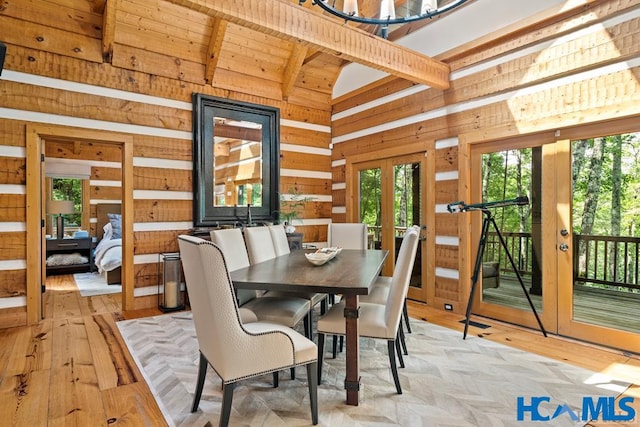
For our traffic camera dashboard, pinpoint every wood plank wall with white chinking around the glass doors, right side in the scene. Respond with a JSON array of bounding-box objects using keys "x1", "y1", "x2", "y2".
[{"x1": 331, "y1": 0, "x2": 640, "y2": 312}]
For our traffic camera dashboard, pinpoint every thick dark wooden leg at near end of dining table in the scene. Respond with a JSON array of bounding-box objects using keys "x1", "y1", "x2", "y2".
[{"x1": 344, "y1": 295, "x2": 360, "y2": 406}]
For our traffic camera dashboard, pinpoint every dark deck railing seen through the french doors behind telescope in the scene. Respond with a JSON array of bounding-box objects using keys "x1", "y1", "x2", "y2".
[{"x1": 483, "y1": 232, "x2": 640, "y2": 289}]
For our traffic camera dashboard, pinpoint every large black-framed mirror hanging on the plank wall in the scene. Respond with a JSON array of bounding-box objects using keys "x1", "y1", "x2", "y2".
[{"x1": 193, "y1": 93, "x2": 280, "y2": 227}]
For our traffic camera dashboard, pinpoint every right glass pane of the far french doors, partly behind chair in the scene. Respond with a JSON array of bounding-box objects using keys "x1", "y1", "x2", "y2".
[{"x1": 393, "y1": 163, "x2": 422, "y2": 288}]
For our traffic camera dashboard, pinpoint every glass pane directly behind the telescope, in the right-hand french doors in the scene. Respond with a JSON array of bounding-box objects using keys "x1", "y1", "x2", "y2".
[{"x1": 478, "y1": 147, "x2": 543, "y2": 312}]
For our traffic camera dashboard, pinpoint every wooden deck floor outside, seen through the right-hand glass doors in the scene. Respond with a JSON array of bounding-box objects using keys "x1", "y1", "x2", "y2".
[{"x1": 483, "y1": 275, "x2": 640, "y2": 333}]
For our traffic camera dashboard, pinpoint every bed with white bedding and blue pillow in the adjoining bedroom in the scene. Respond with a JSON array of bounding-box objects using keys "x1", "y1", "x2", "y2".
[{"x1": 94, "y1": 203, "x2": 122, "y2": 285}]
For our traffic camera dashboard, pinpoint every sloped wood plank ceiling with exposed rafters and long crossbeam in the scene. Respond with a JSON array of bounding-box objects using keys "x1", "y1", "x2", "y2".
[{"x1": 0, "y1": 0, "x2": 458, "y2": 108}]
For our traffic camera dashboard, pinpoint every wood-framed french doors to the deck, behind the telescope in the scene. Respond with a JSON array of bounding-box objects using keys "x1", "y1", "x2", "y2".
[{"x1": 470, "y1": 124, "x2": 640, "y2": 352}]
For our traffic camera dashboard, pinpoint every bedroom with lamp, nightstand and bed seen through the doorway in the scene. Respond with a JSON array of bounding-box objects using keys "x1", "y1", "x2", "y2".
[{"x1": 44, "y1": 137, "x2": 122, "y2": 302}]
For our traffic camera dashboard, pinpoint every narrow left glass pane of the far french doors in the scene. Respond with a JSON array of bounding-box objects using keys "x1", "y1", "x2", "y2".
[{"x1": 358, "y1": 168, "x2": 382, "y2": 249}]
